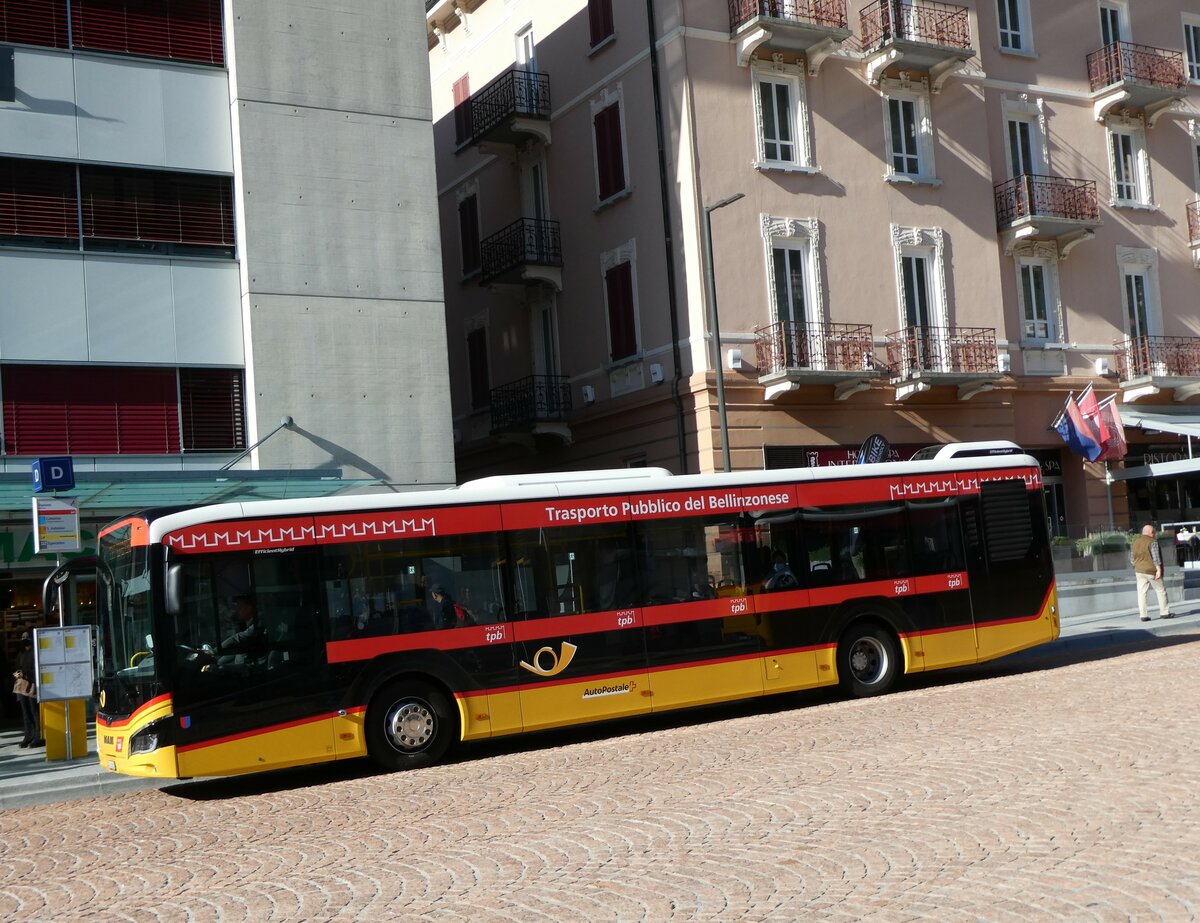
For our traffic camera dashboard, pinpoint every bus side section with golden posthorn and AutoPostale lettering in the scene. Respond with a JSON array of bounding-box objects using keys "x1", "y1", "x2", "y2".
[{"x1": 509, "y1": 522, "x2": 650, "y2": 731}]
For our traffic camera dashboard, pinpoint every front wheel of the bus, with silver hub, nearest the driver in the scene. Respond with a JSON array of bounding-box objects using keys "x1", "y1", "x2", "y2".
[{"x1": 366, "y1": 679, "x2": 458, "y2": 772}]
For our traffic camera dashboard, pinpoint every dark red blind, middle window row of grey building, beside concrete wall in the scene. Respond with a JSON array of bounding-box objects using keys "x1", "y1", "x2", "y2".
[{"x1": 79, "y1": 167, "x2": 234, "y2": 247}]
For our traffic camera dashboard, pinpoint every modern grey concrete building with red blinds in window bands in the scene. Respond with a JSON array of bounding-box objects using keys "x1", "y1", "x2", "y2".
[{"x1": 0, "y1": 0, "x2": 455, "y2": 633}]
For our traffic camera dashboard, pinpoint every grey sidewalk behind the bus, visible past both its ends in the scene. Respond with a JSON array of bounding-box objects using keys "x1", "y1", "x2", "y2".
[{"x1": 0, "y1": 593, "x2": 1200, "y2": 810}]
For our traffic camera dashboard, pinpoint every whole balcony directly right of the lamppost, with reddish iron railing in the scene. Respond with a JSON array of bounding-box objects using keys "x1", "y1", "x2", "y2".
[{"x1": 755, "y1": 320, "x2": 880, "y2": 401}]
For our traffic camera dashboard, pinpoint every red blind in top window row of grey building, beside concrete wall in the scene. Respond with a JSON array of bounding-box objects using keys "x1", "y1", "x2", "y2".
[{"x1": 71, "y1": 0, "x2": 224, "y2": 65}]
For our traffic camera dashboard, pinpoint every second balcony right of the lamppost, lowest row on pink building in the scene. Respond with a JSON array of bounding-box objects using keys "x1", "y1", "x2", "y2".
[{"x1": 886, "y1": 326, "x2": 1001, "y2": 401}]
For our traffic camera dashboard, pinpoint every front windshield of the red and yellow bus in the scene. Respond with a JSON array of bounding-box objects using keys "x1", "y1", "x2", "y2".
[{"x1": 96, "y1": 521, "x2": 158, "y2": 714}]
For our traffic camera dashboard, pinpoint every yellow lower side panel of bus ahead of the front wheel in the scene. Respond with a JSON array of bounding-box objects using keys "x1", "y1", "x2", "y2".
[{"x1": 179, "y1": 718, "x2": 335, "y2": 778}]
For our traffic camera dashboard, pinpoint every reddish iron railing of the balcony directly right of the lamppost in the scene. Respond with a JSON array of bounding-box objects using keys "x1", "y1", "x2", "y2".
[{"x1": 755, "y1": 320, "x2": 875, "y2": 374}]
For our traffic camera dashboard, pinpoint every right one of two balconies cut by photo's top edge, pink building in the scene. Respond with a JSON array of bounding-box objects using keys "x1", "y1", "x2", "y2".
[{"x1": 859, "y1": 0, "x2": 974, "y2": 92}]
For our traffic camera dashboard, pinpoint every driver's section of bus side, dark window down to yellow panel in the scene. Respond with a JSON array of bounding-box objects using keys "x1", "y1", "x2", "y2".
[{"x1": 173, "y1": 549, "x2": 335, "y2": 777}]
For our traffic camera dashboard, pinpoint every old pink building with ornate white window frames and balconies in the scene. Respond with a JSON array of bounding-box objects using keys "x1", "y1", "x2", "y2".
[{"x1": 426, "y1": 0, "x2": 1200, "y2": 534}]
